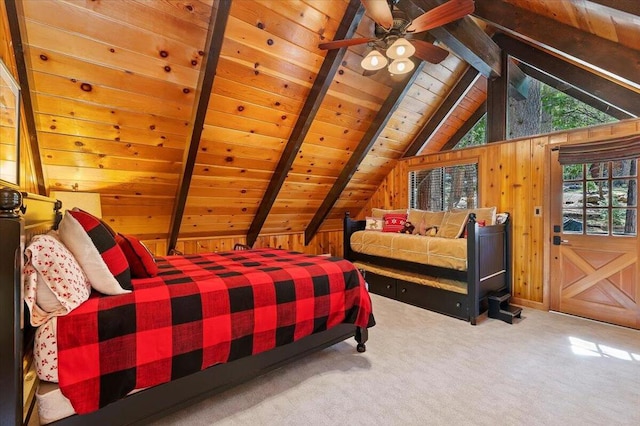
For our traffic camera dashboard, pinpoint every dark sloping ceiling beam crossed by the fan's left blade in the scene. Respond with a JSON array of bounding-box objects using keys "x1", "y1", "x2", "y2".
[{"x1": 247, "y1": 0, "x2": 364, "y2": 246}]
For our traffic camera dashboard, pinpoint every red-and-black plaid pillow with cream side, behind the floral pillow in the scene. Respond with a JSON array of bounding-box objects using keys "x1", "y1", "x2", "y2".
[{"x1": 58, "y1": 210, "x2": 131, "y2": 295}]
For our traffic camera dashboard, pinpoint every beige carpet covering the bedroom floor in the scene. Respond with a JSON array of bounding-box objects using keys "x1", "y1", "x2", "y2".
[{"x1": 153, "y1": 295, "x2": 640, "y2": 426}]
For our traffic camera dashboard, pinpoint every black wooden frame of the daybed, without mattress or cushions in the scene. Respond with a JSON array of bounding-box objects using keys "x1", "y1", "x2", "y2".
[{"x1": 344, "y1": 212, "x2": 511, "y2": 325}]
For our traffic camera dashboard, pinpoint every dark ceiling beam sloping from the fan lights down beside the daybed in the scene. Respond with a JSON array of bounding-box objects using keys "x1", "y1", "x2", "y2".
[{"x1": 304, "y1": 62, "x2": 425, "y2": 245}]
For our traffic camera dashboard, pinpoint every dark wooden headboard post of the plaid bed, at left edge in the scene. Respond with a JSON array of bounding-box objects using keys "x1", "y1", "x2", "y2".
[{"x1": 0, "y1": 188, "x2": 24, "y2": 425}]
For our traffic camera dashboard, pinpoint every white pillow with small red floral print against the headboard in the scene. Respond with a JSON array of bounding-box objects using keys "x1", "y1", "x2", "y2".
[{"x1": 24, "y1": 235, "x2": 91, "y2": 327}]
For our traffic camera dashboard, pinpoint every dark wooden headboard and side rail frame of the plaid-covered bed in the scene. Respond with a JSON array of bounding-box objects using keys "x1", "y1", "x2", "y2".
[{"x1": 0, "y1": 188, "x2": 368, "y2": 426}]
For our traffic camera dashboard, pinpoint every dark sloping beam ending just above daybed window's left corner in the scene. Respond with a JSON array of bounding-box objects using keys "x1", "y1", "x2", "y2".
[{"x1": 403, "y1": 67, "x2": 480, "y2": 158}]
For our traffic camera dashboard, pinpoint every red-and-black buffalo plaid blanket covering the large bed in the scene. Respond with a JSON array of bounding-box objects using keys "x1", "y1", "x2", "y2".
[{"x1": 58, "y1": 249, "x2": 375, "y2": 414}]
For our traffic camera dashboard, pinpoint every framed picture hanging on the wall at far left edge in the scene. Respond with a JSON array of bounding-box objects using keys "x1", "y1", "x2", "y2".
[{"x1": 0, "y1": 60, "x2": 20, "y2": 185}]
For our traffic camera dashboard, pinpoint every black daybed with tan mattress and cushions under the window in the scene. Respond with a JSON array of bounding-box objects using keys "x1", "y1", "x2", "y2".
[{"x1": 344, "y1": 209, "x2": 519, "y2": 325}]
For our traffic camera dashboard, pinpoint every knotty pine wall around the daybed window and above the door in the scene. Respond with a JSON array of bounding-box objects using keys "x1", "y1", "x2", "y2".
[{"x1": 357, "y1": 119, "x2": 640, "y2": 309}]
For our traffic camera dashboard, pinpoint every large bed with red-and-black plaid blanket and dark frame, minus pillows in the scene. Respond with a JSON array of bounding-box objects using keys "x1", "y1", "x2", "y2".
[{"x1": 0, "y1": 188, "x2": 375, "y2": 425}]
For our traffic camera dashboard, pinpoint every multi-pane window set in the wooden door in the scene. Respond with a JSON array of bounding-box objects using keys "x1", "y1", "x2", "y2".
[{"x1": 562, "y1": 159, "x2": 638, "y2": 236}]
